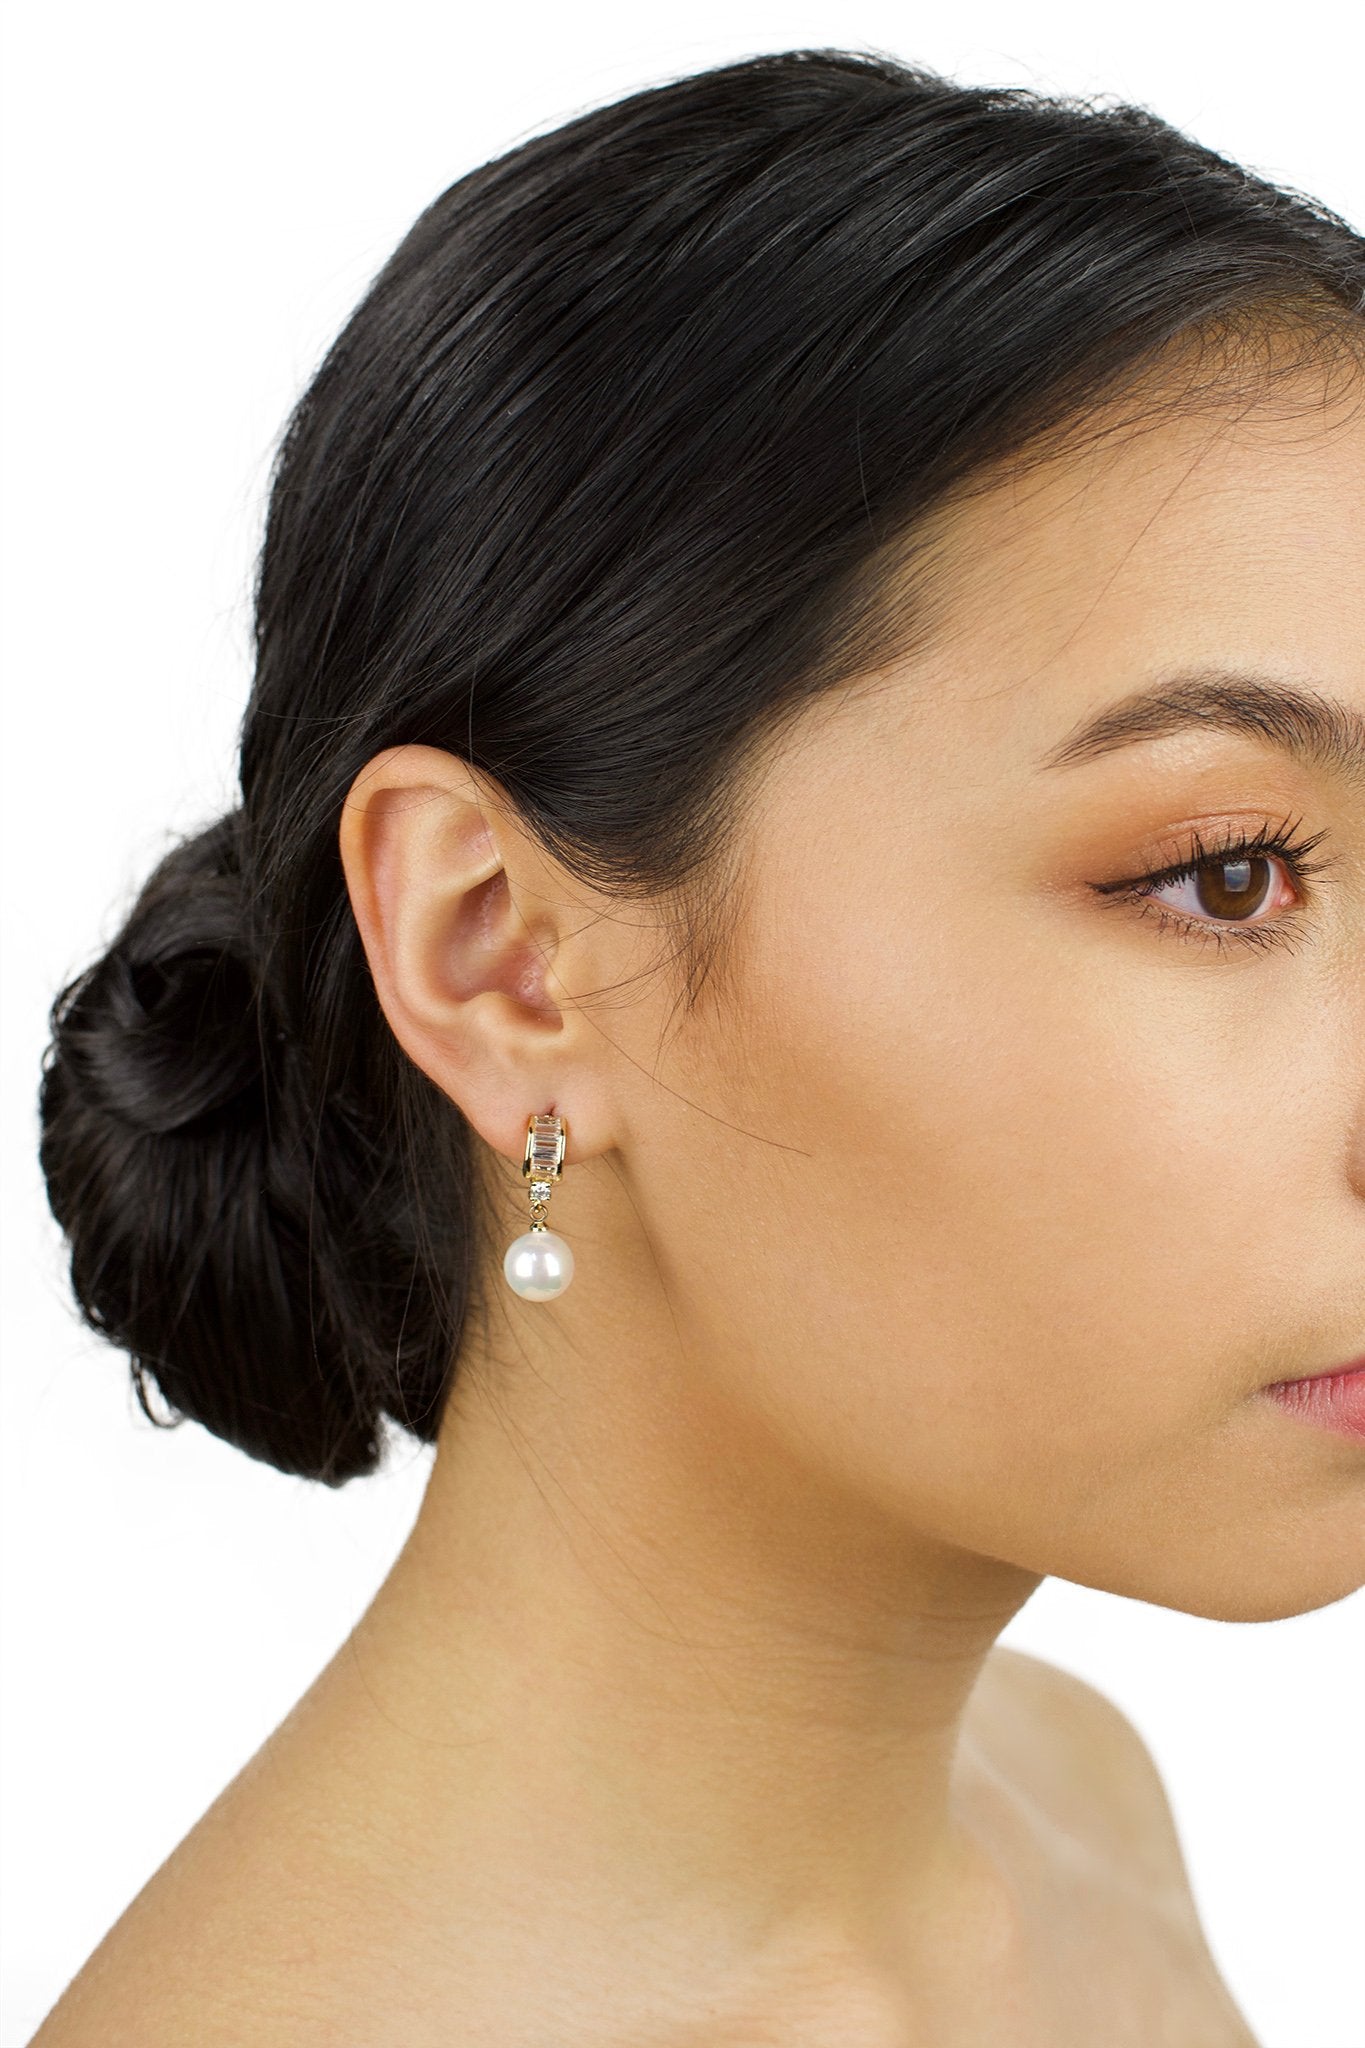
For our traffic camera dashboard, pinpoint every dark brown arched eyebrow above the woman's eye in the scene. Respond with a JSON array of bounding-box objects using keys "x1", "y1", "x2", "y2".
[{"x1": 1036, "y1": 668, "x2": 1365, "y2": 784}]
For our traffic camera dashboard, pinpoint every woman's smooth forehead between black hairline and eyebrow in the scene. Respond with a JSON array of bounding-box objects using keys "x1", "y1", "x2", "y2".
[{"x1": 863, "y1": 367, "x2": 1365, "y2": 748}]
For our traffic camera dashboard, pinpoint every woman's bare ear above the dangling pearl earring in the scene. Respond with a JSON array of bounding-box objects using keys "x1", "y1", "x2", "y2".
[{"x1": 340, "y1": 745, "x2": 620, "y2": 1165}]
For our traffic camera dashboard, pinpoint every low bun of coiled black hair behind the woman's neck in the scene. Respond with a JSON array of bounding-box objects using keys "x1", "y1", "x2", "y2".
[{"x1": 39, "y1": 811, "x2": 463, "y2": 1485}]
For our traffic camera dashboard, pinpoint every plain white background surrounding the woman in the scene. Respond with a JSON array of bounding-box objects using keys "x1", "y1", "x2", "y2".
[{"x1": 0, "y1": 0, "x2": 1365, "y2": 2048}]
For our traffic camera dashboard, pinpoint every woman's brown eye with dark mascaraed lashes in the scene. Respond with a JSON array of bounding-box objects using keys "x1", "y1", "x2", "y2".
[{"x1": 1095, "y1": 823, "x2": 1334, "y2": 950}]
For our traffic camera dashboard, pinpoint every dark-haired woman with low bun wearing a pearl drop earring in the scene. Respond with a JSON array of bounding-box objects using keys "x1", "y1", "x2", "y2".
[{"x1": 37, "y1": 39, "x2": 1365, "y2": 2048}]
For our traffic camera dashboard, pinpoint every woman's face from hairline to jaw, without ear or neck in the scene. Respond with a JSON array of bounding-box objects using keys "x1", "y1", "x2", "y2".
[{"x1": 581, "y1": 360, "x2": 1365, "y2": 1618}]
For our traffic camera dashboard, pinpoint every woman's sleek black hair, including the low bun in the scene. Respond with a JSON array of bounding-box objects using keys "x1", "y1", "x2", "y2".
[{"x1": 39, "y1": 49, "x2": 1365, "y2": 1485}]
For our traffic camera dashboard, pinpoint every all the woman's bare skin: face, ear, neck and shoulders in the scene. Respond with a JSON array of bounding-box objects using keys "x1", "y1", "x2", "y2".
[{"x1": 26, "y1": 360, "x2": 1365, "y2": 2048}]
